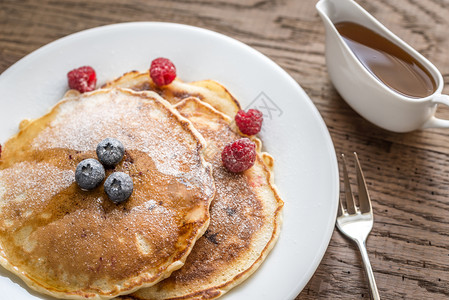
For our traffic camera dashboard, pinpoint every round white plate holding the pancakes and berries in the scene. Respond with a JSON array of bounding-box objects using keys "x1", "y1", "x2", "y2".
[{"x1": 0, "y1": 22, "x2": 339, "y2": 300}]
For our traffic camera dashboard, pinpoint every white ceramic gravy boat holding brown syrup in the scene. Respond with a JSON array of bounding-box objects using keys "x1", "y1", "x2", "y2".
[{"x1": 316, "y1": 0, "x2": 449, "y2": 132}]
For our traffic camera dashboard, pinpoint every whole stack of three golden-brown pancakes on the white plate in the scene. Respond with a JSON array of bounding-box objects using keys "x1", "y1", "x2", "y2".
[{"x1": 0, "y1": 72, "x2": 283, "y2": 299}]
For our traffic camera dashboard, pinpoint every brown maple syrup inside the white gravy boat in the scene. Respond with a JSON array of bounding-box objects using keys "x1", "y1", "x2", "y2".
[{"x1": 335, "y1": 22, "x2": 437, "y2": 98}]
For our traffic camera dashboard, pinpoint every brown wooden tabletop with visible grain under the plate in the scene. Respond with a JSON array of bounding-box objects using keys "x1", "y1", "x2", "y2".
[{"x1": 0, "y1": 0, "x2": 449, "y2": 300}]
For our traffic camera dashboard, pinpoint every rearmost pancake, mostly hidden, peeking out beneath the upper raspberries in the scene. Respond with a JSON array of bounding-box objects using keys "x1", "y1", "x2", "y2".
[{"x1": 103, "y1": 71, "x2": 240, "y2": 118}]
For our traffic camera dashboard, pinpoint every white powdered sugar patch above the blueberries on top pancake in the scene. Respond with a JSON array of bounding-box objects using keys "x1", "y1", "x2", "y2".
[{"x1": 32, "y1": 88, "x2": 197, "y2": 176}]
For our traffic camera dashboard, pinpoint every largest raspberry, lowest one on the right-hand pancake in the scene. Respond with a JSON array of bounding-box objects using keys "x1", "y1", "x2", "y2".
[{"x1": 221, "y1": 138, "x2": 256, "y2": 173}]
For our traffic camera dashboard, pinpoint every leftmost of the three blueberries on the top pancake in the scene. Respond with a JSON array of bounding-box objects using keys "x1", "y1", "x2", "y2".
[{"x1": 75, "y1": 158, "x2": 105, "y2": 190}]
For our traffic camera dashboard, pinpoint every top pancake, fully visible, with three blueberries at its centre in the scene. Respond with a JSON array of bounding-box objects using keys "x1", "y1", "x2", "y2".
[{"x1": 0, "y1": 89, "x2": 215, "y2": 299}]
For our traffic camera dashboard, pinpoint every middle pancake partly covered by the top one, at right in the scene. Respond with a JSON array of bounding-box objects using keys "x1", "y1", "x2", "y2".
[{"x1": 117, "y1": 98, "x2": 283, "y2": 300}]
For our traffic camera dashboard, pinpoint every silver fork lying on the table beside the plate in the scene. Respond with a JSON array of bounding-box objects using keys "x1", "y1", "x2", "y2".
[{"x1": 337, "y1": 152, "x2": 380, "y2": 300}]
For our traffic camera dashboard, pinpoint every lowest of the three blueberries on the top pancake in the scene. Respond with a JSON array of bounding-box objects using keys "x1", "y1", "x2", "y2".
[{"x1": 104, "y1": 172, "x2": 133, "y2": 203}]
